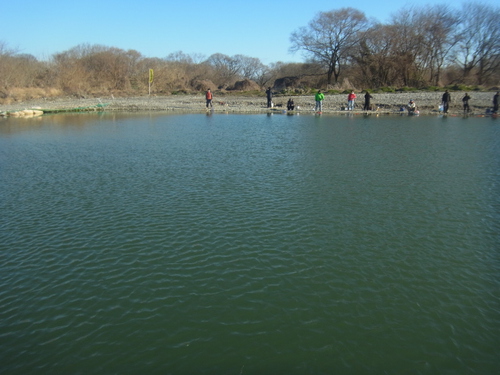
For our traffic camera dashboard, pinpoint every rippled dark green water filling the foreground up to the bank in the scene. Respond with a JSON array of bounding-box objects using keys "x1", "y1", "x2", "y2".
[{"x1": 0, "y1": 114, "x2": 500, "y2": 375}]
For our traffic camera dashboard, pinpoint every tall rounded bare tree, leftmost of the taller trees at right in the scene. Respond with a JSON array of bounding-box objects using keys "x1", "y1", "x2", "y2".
[{"x1": 290, "y1": 8, "x2": 369, "y2": 84}]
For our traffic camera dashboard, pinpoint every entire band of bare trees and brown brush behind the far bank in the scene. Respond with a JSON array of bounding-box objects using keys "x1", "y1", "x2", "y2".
[{"x1": 0, "y1": 3, "x2": 500, "y2": 103}]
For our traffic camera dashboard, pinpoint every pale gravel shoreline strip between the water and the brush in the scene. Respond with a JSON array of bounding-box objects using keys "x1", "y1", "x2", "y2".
[{"x1": 0, "y1": 92, "x2": 495, "y2": 115}]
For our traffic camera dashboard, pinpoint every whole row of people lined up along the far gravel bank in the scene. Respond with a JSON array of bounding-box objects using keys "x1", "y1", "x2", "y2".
[{"x1": 205, "y1": 87, "x2": 499, "y2": 114}]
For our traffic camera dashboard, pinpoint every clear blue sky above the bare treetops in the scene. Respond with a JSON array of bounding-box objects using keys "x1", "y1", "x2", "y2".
[{"x1": 0, "y1": 0, "x2": 498, "y2": 64}]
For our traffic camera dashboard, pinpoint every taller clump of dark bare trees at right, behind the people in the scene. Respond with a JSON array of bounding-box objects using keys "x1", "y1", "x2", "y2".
[{"x1": 291, "y1": 3, "x2": 500, "y2": 87}]
